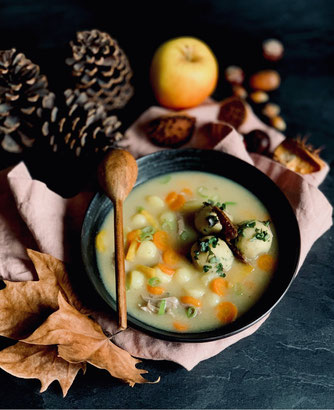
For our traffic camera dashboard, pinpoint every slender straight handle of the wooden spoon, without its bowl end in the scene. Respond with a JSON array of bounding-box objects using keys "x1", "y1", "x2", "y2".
[{"x1": 114, "y1": 199, "x2": 127, "y2": 330}]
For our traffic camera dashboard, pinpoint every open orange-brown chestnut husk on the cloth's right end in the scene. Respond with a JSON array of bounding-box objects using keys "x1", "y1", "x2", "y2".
[{"x1": 274, "y1": 138, "x2": 325, "y2": 174}]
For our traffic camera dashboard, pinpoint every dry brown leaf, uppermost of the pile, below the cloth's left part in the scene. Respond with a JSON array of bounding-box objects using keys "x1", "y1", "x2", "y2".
[{"x1": 0, "y1": 249, "x2": 81, "y2": 340}]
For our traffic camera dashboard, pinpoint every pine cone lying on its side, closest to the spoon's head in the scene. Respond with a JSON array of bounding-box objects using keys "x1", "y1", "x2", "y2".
[{"x1": 38, "y1": 89, "x2": 123, "y2": 157}]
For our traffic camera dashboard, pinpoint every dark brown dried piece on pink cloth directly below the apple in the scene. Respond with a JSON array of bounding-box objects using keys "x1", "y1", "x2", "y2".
[{"x1": 146, "y1": 114, "x2": 196, "y2": 148}]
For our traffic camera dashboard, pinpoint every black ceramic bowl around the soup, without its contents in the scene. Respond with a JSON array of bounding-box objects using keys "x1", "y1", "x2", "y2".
[{"x1": 81, "y1": 149, "x2": 300, "y2": 342}]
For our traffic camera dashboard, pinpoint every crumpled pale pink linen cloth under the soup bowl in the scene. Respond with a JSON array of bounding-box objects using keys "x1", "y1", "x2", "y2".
[{"x1": 0, "y1": 103, "x2": 332, "y2": 370}]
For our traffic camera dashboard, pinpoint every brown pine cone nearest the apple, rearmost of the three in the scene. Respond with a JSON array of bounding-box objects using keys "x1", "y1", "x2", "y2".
[{"x1": 66, "y1": 30, "x2": 133, "y2": 110}]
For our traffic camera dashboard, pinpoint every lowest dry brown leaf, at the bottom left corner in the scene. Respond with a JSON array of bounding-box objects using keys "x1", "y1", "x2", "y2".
[{"x1": 0, "y1": 342, "x2": 86, "y2": 397}]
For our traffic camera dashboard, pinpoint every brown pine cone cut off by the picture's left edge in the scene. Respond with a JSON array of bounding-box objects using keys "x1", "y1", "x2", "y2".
[{"x1": 0, "y1": 48, "x2": 50, "y2": 153}]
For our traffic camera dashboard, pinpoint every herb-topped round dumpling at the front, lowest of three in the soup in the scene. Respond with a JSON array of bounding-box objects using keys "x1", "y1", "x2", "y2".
[{"x1": 191, "y1": 236, "x2": 234, "y2": 274}]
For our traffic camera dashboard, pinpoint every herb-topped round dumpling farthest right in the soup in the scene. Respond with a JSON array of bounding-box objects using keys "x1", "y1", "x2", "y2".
[{"x1": 235, "y1": 220, "x2": 273, "y2": 259}]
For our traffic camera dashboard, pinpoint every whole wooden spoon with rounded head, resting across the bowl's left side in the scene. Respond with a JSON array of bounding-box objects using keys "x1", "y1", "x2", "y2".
[{"x1": 97, "y1": 149, "x2": 138, "y2": 331}]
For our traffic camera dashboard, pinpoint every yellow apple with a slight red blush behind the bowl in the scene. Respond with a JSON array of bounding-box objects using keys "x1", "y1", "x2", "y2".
[{"x1": 150, "y1": 37, "x2": 218, "y2": 109}]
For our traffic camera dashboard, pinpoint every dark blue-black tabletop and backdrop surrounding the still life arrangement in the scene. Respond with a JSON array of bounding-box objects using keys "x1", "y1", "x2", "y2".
[{"x1": 0, "y1": 0, "x2": 334, "y2": 408}]
